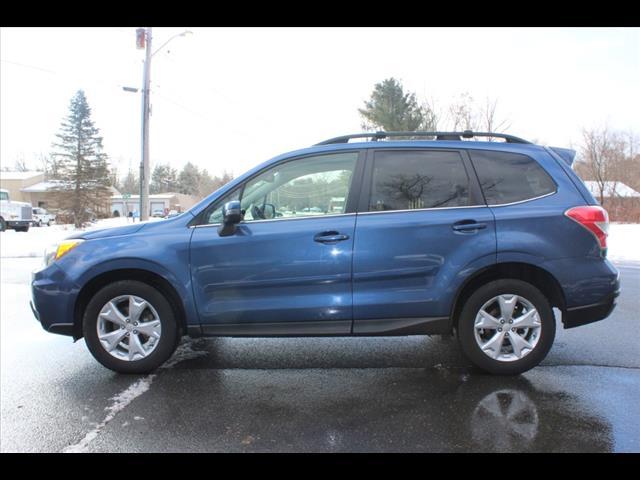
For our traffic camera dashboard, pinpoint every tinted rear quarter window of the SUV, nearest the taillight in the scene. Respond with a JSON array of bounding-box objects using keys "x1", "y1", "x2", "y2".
[{"x1": 469, "y1": 150, "x2": 556, "y2": 205}]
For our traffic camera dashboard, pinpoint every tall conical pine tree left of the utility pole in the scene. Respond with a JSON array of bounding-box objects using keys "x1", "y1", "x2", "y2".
[{"x1": 51, "y1": 90, "x2": 111, "y2": 227}]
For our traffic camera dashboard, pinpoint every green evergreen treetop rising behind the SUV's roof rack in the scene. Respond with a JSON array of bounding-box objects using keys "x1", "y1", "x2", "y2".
[{"x1": 358, "y1": 77, "x2": 435, "y2": 132}]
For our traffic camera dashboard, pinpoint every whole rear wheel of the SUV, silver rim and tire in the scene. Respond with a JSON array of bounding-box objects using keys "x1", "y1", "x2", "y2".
[{"x1": 458, "y1": 279, "x2": 556, "y2": 375}]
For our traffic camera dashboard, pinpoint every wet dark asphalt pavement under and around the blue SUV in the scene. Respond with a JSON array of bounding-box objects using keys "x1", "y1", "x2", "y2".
[{"x1": 0, "y1": 258, "x2": 640, "y2": 452}]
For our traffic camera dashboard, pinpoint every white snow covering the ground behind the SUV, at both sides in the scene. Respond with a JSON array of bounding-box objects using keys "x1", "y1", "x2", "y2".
[{"x1": 0, "y1": 217, "x2": 640, "y2": 262}]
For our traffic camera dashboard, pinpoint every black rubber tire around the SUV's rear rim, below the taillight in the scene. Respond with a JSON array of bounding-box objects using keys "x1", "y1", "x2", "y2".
[{"x1": 457, "y1": 279, "x2": 556, "y2": 375}]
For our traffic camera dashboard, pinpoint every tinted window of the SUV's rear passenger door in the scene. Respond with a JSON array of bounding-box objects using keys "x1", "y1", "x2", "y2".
[{"x1": 369, "y1": 150, "x2": 469, "y2": 211}]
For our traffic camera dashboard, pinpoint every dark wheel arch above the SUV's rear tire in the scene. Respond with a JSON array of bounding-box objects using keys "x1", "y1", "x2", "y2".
[{"x1": 450, "y1": 262, "x2": 566, "y2": 328}]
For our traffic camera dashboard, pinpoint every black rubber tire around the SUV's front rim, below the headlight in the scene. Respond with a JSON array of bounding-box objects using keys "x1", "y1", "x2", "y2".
[{"x1": 82, "y1": 280, "x2": 180, "y2": 374}]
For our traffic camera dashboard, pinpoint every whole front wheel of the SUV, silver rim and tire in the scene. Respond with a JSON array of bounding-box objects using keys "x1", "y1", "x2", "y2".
[{"x1": 83, "y1": 280, "x2": 180, "y2": 373}]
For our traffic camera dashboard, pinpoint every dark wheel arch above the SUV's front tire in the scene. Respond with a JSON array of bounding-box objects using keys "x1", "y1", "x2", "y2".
[{"x1": 73, "y1": 268, "x2": 187, "y2": 340}]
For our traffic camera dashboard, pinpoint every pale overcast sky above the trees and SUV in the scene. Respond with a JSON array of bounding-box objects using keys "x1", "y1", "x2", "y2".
[{"x1": 0, "y1": 27, "x2": 640, "y2": 175}]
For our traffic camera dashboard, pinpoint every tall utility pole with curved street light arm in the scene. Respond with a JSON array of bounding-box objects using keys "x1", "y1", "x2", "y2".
[{"x1": 134, "y1": 27, "x2": 193, "y2": 221}]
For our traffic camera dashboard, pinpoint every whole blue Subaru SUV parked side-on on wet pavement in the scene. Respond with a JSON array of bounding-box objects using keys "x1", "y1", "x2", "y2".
[{"x1": 31, "y1": 131, "x2": 619, "y2": 374}]
